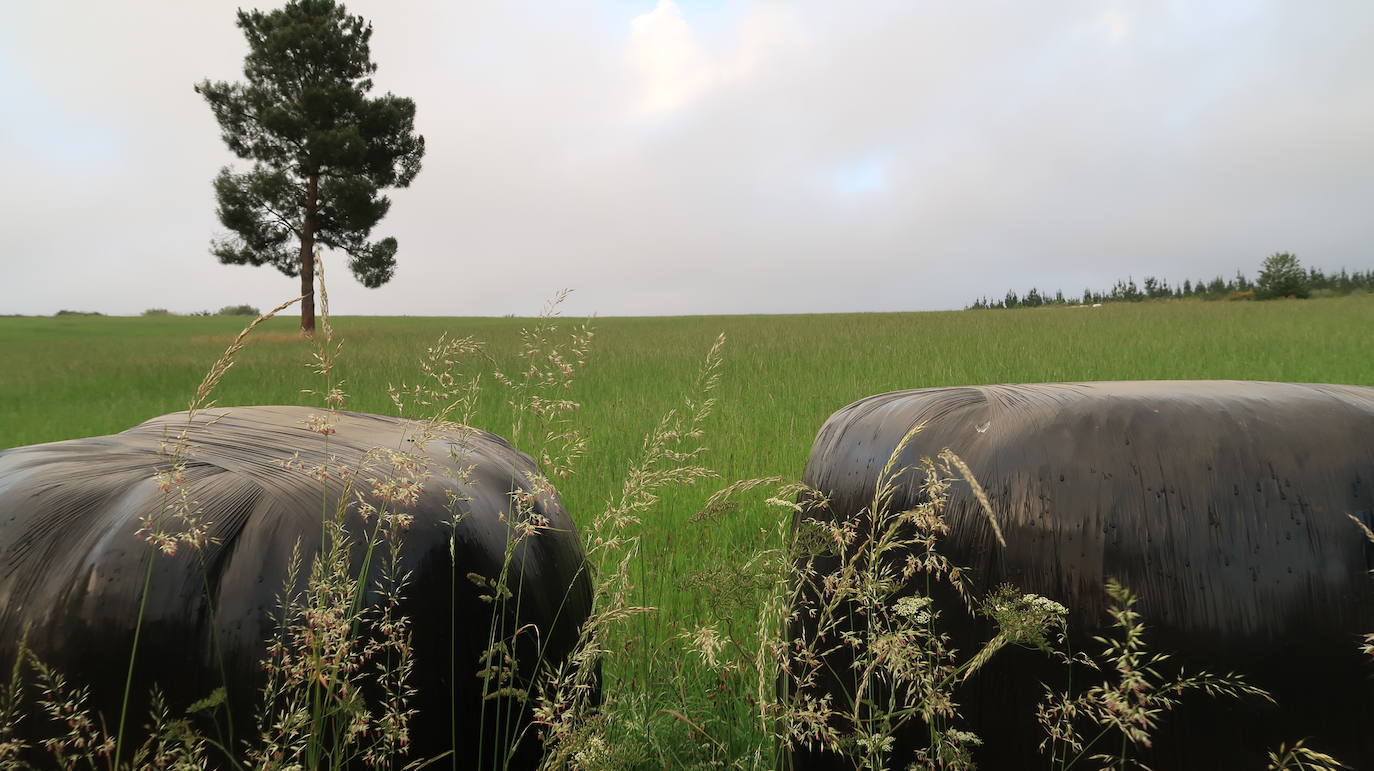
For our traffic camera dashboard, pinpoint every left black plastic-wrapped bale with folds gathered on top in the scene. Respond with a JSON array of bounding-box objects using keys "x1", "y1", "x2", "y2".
[{"x1": 0, "y1": 407, "x2": 591, "y2": 767}]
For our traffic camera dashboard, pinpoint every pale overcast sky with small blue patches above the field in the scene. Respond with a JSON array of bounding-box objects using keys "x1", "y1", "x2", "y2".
[{"x1": 0, "y1": 0, "x2": 1374, "y2": 315}]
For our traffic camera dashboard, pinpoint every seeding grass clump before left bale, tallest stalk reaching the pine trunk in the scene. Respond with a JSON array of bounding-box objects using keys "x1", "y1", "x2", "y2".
[{"x1": 249, "y1": 260, "x2": 430, "y2": 768}]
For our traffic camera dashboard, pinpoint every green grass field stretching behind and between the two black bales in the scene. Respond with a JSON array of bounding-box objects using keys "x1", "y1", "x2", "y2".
[{"x1": 0, "y1": 297, "x2": 1374, "y2": 767}]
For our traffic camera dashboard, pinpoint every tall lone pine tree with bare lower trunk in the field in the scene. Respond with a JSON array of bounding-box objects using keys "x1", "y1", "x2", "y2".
[{"x1": 195, "y1": 0, "x2": 425, "y2": 333}]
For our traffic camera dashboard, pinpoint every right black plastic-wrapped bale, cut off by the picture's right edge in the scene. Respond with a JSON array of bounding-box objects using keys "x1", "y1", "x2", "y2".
[{"x1": 794, "y1": 381, "x2": 1374, "y2": 770}]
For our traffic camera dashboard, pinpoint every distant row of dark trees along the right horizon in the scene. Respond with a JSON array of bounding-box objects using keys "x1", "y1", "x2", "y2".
[{"x1": 966, "y1": 253, "x2": 1374, "y2": 309}]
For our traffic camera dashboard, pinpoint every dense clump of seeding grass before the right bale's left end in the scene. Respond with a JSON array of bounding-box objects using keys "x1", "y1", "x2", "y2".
[{"x1": 778, "y1": 434, "x2": 1065, "y2": 770}]
